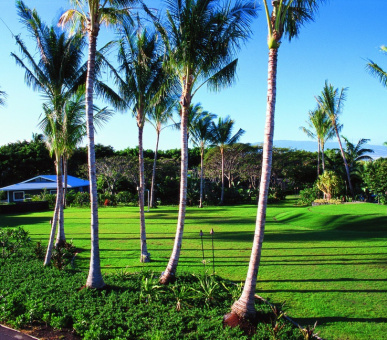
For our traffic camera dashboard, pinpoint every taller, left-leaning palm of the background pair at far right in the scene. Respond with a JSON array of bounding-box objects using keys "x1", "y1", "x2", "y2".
[{"x1": 316, "y1": 81, "x2": 355, "y2": 197}]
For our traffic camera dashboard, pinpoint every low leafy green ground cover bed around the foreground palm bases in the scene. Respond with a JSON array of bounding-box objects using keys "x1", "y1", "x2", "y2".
[{"x1": 0, "y1": 239, "x2": 312, "y2": 339}]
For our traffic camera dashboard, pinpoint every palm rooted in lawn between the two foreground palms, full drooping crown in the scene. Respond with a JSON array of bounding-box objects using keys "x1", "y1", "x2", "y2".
[{"x1": 112, "y1": 25, "x2": 166, "y2": 262}]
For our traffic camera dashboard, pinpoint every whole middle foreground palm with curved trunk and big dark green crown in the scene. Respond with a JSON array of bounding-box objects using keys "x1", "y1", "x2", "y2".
[{"x1": 156, "y1": 0, "x2": 256, "y2": 284}]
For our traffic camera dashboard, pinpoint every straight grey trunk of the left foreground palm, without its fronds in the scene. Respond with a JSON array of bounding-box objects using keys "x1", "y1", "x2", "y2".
[{"x1": 86, "y1": 31, "x2": 105, "y2": 288}]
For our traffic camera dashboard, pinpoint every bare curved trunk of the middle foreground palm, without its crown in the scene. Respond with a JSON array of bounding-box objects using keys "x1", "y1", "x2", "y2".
[{"x1": 160, "y1": 89, "x2": 191, "y2": 284}]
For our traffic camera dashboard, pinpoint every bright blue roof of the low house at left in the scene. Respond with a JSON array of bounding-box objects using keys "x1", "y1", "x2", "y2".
[{"x1": 0, "y1": 175, "x2": 89, "y2": 191}]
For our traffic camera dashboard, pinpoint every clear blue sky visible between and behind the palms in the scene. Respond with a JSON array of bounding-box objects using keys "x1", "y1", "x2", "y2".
[{"x1": 0, "y1": 0, "x2": 387, "y2": 150}]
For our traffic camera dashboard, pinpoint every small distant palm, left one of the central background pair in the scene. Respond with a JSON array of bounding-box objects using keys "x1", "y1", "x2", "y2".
[{"x1": 191, "y1": 111, "x2": 216, "y2": 208}]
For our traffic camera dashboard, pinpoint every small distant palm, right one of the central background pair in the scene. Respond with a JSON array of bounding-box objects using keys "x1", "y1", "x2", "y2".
[{"x1": 211, "y1": 117, "x2": 245, "y2": 205}]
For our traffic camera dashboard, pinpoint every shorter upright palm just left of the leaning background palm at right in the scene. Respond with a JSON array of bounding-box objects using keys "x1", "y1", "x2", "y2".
[{"x1": 300, "y1": 109, "x2": 335, "y2": 177}]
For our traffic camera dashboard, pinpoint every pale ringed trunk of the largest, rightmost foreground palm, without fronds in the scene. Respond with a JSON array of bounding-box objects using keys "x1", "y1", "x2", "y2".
[{"x1": 224, "y1": 49, "x2": 278, "y2": 326}]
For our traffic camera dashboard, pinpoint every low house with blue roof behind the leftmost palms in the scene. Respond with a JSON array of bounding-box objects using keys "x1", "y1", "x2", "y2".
[{"x1": 0, "y1": 175, "x2": 89, "y2": 202}]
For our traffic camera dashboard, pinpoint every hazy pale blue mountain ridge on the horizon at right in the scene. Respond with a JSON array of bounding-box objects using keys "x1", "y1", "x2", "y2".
[{"x1": 258, "y1": 140, "x2": 387, "y2": 159}]
